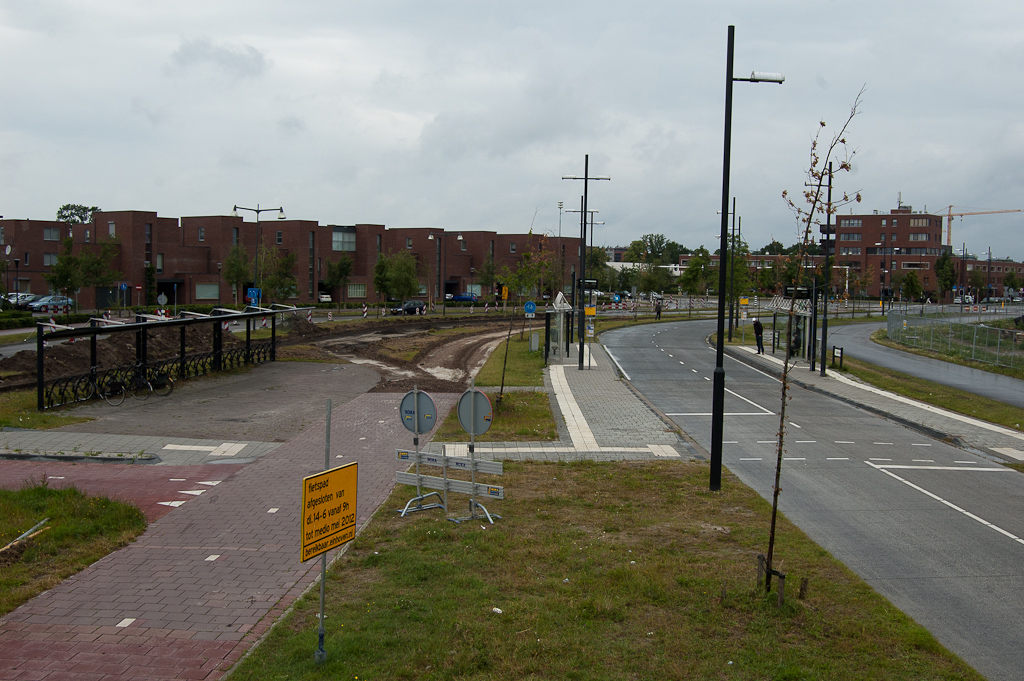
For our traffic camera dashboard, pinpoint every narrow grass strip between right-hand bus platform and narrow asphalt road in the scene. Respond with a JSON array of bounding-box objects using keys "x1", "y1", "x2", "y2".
[{"x1": 843, "y1": 357, "x2": 1024, "y2": 430}]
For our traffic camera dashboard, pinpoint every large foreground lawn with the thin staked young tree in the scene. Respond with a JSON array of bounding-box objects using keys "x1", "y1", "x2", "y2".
[{"x1": 232, "y1": 462, "x2": 981, "y2": 681}]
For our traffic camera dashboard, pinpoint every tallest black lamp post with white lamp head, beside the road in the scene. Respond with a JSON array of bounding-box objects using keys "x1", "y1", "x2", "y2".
[{"x1": 711, "y1": 26, "x2": 785, "y2": 492}]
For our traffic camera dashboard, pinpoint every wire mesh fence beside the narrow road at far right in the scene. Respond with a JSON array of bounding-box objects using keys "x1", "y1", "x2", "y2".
[{"x1": 888, "y1": 311, "x2": 1024, "y2": 369}]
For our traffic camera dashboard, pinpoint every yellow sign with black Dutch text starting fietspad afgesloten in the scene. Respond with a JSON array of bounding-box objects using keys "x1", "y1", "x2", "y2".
[{"x1": 300, "y1": 461, "x2": 358, "y2": 561}]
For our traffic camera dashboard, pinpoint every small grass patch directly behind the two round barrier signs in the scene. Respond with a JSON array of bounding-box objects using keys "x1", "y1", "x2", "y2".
[{"x1": 432, "y1": 392, "x2": 558, "y2": 442}]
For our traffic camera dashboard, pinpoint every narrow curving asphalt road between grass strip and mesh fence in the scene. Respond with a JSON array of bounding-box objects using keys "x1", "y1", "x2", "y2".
[{"x1": 828, "y1": 322, "x2": 1024, "y2": 409}]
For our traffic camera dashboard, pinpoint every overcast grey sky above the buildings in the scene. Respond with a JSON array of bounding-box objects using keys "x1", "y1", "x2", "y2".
[{"x1": 0, "y1": 0, "x2": 1024, "y2": 260}]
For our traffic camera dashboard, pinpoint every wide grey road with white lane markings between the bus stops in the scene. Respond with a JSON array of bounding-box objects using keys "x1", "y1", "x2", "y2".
[{"x1": 602, "y1": 322, "x2": 1024, "y2": 680}]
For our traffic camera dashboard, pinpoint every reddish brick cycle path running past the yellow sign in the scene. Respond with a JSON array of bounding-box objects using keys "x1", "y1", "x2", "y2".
[{"x1": 0, "y1": 393, "x2": 458, "y2": 681}]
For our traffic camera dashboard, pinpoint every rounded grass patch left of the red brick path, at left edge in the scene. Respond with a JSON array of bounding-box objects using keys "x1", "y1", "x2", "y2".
[{"x1": 0, "y1": 479, "x2": 145, "y2": 615}]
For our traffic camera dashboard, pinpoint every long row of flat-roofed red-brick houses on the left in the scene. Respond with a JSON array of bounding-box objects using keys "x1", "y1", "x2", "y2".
[{"x1": 0, "y1": 211, "x2": 579, "y2": 309}]
